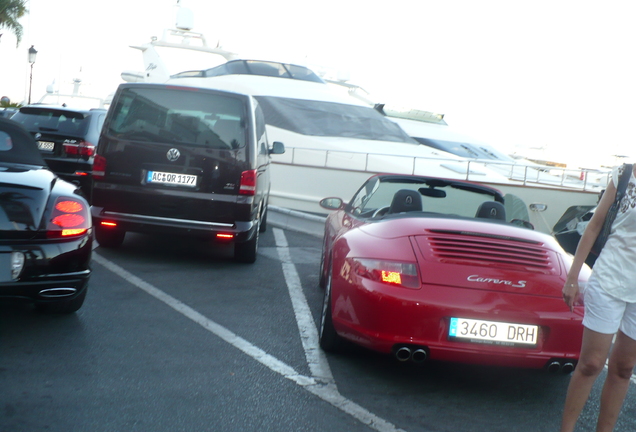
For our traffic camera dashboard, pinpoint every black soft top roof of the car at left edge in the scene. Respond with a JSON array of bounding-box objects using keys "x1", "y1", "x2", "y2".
[{"x1": 0, "y1": 118, "x2": 46, "y2": 166}]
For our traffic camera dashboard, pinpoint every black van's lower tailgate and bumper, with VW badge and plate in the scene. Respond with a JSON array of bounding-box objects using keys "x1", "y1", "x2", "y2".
[{"x1": 93, "y1": 140, "x2": 249, "y2": 222}]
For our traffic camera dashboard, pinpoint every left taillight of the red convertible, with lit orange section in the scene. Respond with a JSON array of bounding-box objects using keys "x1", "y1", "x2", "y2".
[{"x1": 351, "y1": 258, "x2": 420, "y2": 289}]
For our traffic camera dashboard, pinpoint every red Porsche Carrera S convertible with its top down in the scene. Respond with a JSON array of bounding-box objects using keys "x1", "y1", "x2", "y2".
[{"x1": 320, "y1": 175, "x2": 590, "y2": 372}]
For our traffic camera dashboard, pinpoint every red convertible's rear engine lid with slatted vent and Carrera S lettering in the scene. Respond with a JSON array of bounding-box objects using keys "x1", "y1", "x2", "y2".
[{"x1": 360, "y1": 217, "x2": 572, "y2": 297}]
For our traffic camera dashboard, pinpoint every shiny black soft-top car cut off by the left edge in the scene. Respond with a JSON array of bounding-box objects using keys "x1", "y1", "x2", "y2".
[{"x1": 0, "y1": 118, "x2": 92, "y2": 313}]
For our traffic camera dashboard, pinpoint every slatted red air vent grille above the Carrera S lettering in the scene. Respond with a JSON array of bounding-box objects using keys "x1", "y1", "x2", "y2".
[{"x1": 428, "y1": 232, "x2": 554, "y2": 271}]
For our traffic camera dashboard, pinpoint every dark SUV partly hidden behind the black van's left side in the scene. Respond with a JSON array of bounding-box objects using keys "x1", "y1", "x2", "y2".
[{"x1": 11, "y1": 104, "x2": 106, "y2": 202}]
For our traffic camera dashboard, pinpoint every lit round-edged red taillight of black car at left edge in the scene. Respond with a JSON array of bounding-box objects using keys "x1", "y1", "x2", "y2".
[{"x1": 46, "y1": 197, "x2": 91, "y2": 238}]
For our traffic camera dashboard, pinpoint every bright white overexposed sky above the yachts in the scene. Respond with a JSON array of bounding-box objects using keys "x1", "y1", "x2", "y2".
[{"x1": 0, "y1": 0, "x2": 636, "y2": 167}]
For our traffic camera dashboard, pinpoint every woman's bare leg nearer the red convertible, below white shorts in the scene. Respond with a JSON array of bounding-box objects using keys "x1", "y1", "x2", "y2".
[{"x1": 561, "y1": 328, "x2": 614, "y2": 432}]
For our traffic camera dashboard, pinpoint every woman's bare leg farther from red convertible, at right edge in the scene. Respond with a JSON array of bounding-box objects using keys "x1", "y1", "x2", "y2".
[{"x1": 596, "y1": 331, "x2": 636, "y2": 432}]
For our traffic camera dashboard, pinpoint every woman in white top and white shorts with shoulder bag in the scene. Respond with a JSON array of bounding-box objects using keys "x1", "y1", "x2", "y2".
[{"x1": 561, "y1": 165, "x2": 636, "y2": 432}]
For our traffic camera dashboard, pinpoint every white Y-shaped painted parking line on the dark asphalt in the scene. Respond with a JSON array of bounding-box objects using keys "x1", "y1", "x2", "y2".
[{"x1": 93, "y1": 250, "x2": 404, "y2": 432}]
